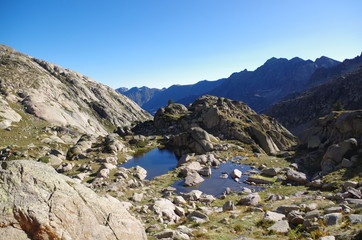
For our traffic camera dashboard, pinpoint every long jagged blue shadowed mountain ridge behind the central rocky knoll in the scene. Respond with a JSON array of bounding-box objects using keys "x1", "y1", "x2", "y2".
[{"x1": 120, "y1": 57, "x2": 339, "y2": 113}]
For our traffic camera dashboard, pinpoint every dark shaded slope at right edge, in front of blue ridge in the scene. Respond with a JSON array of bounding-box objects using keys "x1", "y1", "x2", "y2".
[{"x1": 267, "y1": 64, "x2": 362, "y2": 133}]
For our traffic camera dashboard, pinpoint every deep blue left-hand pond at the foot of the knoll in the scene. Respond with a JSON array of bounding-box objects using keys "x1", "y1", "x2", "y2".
[{"x1": 118, "y1": 148, "x2": 177, "y2": 180}]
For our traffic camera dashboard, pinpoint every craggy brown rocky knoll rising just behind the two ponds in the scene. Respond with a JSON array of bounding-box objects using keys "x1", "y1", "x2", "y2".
[{"x1": 154, "y1": 95, "x2": 296, "y2": 154}]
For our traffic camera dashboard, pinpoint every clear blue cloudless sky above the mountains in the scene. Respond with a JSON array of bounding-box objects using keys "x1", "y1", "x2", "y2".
[{"x1": 0, "y1": 0, "x2": 362, "y2": 88}]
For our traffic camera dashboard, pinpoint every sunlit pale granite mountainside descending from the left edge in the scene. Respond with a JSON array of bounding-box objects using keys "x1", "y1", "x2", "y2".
[{"x1": 0, "y1": 45, "x2": 150, "y2": 135}]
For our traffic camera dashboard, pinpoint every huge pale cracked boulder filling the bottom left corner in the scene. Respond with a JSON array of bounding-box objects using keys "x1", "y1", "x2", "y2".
[{"x1": 0, "y1": 160, "x2": 147, "y2": 240}]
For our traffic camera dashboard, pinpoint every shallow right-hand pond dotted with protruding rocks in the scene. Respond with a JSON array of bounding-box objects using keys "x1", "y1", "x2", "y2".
[{"x1": 172, "y1": 162, "x2": 261, "y2": 197}]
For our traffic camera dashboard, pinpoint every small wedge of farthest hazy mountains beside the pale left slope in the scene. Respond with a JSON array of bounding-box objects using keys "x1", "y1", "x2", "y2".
[{"x1": 116, "y1": 86, "x2": 164, "y2": 106}]
